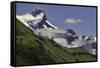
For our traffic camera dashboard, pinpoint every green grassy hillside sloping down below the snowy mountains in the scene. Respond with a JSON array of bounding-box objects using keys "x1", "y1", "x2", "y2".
[{"x1": 16, "y1": 20, "x2": 96, "y2": 65}]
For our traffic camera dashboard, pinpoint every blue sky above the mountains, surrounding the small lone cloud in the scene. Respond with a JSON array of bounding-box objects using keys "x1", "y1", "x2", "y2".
[{"x1": 16, "y1": 3, "x2": 96, "y2": 36}]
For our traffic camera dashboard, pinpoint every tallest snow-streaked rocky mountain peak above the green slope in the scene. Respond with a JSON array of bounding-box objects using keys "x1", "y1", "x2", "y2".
[{"x1": 17, "y1": 9, "x2": 57, "y2": 30}]
